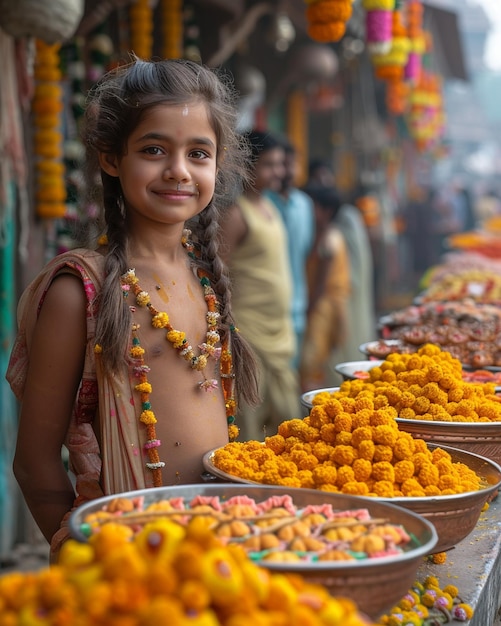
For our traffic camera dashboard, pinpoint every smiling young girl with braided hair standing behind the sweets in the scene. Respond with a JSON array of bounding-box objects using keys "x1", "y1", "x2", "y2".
[{"x1": 7, "y1": 60, "x2": 257, "y2": 555}]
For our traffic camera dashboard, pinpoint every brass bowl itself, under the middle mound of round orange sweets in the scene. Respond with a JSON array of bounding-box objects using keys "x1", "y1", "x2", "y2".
[{"x1": 204, "y1": 443, "x2": 501, "y2": 552}]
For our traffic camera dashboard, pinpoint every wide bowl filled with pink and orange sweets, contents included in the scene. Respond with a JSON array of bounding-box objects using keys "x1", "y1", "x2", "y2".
[{"x1": 70, "y1": 483, "x2": 437, "y2": 626}]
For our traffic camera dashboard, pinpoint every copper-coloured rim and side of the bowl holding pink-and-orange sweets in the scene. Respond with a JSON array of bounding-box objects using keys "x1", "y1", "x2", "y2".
[{"x1": 69, "y1": 484, "x2": 437, "y2": 619}]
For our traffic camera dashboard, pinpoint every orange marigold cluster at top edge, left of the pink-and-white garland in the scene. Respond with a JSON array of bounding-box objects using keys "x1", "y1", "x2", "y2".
[{"x1": 305, "y1": 0, "x2": 353, "y2": 43}]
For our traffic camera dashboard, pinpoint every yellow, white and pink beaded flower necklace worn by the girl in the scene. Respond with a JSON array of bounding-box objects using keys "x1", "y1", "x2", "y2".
[{"x1": 120, "y1": 229, "x2": 239, "y2": 487}]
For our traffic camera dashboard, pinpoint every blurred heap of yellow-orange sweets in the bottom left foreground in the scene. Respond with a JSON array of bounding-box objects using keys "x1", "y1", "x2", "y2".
[{"x1": 0, "y1": 518, "x2": 369, "y2": 626}]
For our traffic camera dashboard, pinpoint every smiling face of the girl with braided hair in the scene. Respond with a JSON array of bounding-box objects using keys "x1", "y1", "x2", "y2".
[{"x1": 100, "y1": 103, "x2": 217, "y2": 225}]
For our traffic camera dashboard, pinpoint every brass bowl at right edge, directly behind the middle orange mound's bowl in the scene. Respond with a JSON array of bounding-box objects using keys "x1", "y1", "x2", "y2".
[{"x1": 397, "y1": 417, "x2": 501, "y2": 465}]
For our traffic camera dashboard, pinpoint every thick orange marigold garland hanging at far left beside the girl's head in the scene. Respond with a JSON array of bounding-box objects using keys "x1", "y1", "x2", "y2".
[{"x1": 32, "y1": 40, "x2": 66, "y2": 218}]
